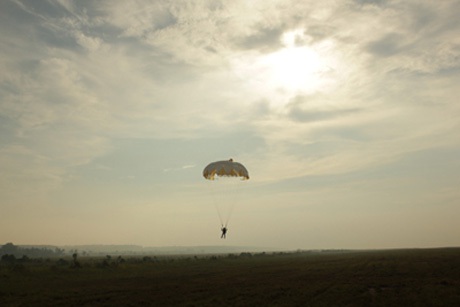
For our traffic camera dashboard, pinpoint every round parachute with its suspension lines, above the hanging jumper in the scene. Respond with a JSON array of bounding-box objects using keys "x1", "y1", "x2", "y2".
[{"x1": 203, "y1": 159, "x2": 249, "y2": 227}]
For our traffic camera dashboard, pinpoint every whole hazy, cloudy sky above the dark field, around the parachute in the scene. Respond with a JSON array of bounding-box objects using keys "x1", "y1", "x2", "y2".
[{"x1": 0, "y1": 0, "x2": 460, "y2": 249}]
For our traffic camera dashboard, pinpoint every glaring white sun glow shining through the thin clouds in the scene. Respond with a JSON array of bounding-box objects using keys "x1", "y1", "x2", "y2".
[{"x1": 235, "y1": 31, "x2": 335, "y2": 101}]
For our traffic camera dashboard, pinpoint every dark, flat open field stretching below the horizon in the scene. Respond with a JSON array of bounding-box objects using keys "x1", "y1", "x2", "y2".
[{"x1": 0, "y1": 248, "x2": 460, "y2": 306}]
